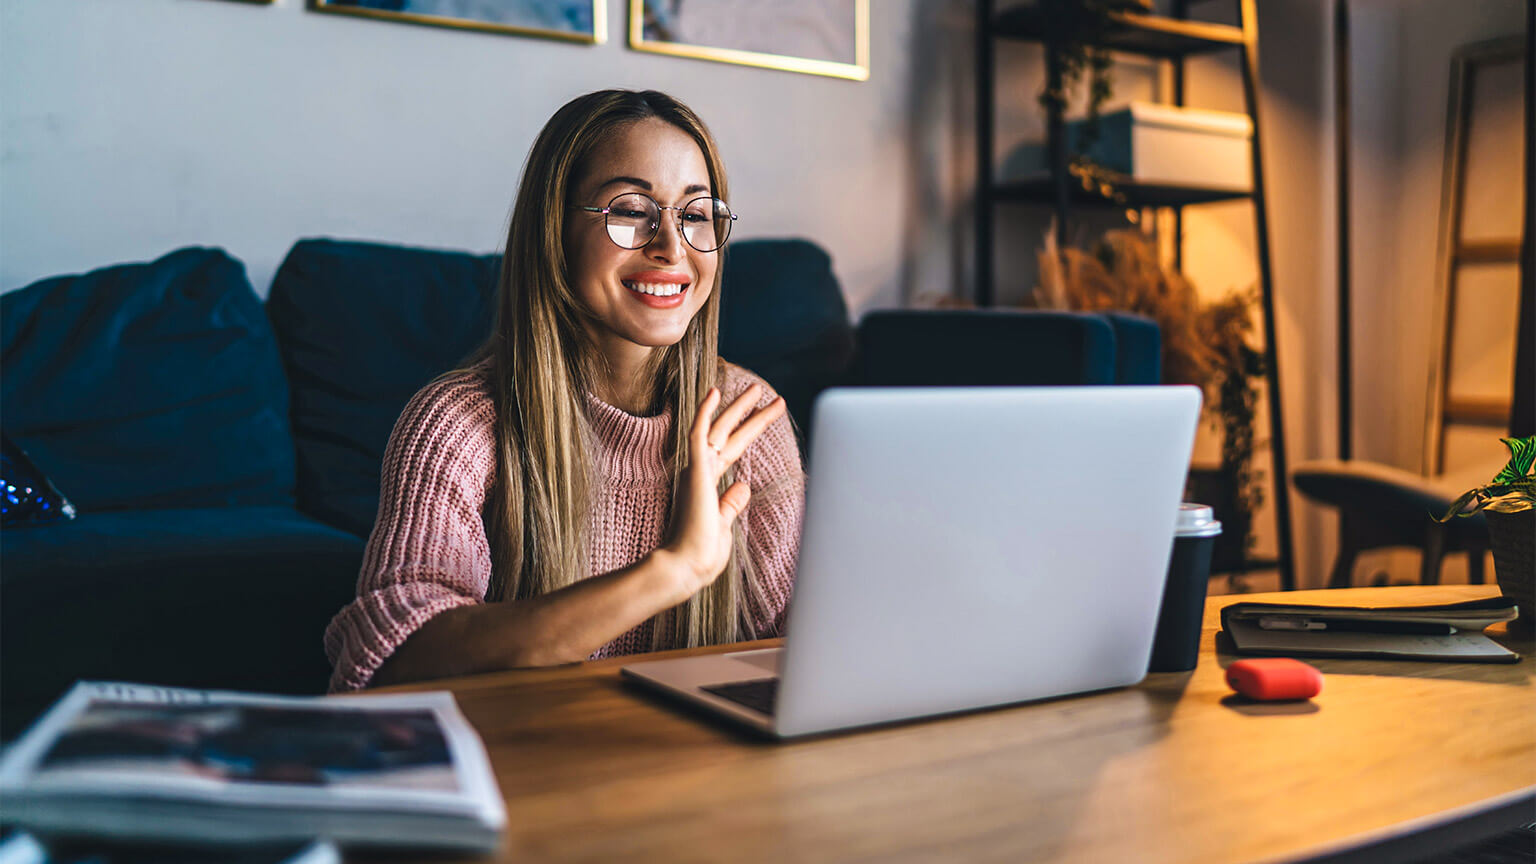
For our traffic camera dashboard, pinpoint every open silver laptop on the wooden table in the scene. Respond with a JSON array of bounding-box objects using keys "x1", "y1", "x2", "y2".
[{"x1": 622, "y1": 386, "x2": 1200, "y2": 738}]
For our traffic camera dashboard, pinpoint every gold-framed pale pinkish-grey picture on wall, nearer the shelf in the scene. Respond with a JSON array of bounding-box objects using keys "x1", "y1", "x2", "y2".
[{"x1": 630, "y1": 0, "x2": 869, "y2": 81}]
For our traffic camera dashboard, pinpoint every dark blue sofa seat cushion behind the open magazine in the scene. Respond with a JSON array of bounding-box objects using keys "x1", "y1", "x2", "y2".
[{"x1": 0, "y1": 507, "x2": 362, "y2": 738}]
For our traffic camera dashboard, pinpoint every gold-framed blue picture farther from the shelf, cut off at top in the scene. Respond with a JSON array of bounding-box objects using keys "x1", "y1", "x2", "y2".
[{"x1": 309, "y1": 0, "x2": 608, "y2": 45}]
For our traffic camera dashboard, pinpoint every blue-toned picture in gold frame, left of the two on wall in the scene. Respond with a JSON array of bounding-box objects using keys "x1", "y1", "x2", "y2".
[{"x1": 309, "y1": 0, "x2": 608, "y2": 45}]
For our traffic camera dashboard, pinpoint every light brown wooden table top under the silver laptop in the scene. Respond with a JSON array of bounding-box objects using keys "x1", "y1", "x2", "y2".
[{"x1": 365, "y1": 586, "x2": 1536, "y2": 862}]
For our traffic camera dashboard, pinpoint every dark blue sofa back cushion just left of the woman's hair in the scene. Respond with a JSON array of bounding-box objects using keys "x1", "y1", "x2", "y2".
[{"x1": 267, "y1": 240, "x2": 501, "y2": 537}]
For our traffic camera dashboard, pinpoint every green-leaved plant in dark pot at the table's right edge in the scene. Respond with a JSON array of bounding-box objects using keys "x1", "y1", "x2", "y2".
[{"x1": 1438, "y1": 435, "x2": 1536, "y2": 632}]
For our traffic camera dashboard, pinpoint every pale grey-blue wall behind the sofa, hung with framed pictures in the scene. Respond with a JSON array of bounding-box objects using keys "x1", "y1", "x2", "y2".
[{"x1": 0, "y1": 0, "x2": 927, "y2": 309}]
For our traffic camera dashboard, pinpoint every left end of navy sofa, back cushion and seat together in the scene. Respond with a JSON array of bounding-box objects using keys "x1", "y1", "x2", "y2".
[{"x1": 0, "y1": 249, "x2": 362, "y2": 736}]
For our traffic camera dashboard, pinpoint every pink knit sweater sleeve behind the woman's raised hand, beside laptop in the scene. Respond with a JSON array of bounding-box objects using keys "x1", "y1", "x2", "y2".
[{"x1": 723, "y1": 366, "x2": 805, "y2": 638}]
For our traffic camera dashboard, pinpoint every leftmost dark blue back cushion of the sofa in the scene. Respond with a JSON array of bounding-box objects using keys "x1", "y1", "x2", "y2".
[{"x1": 0, "y1": 249, "x2": 293, "y2": 512}]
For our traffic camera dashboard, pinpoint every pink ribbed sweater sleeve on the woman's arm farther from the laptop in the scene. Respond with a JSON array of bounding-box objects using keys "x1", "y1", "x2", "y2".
[{"x1": 326, "y1": 377, "x2": 496, "y2": 692}]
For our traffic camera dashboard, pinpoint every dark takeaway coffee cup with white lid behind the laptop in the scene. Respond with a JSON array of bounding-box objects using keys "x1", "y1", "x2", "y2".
[{"x1": 1147, "y1": 504, "x2": 1221, "y2": 672}]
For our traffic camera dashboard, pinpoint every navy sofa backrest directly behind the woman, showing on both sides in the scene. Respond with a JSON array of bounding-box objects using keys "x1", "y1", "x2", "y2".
[{"x1": 267, "y1": 232, "x2": 852, "y2": 535}]
